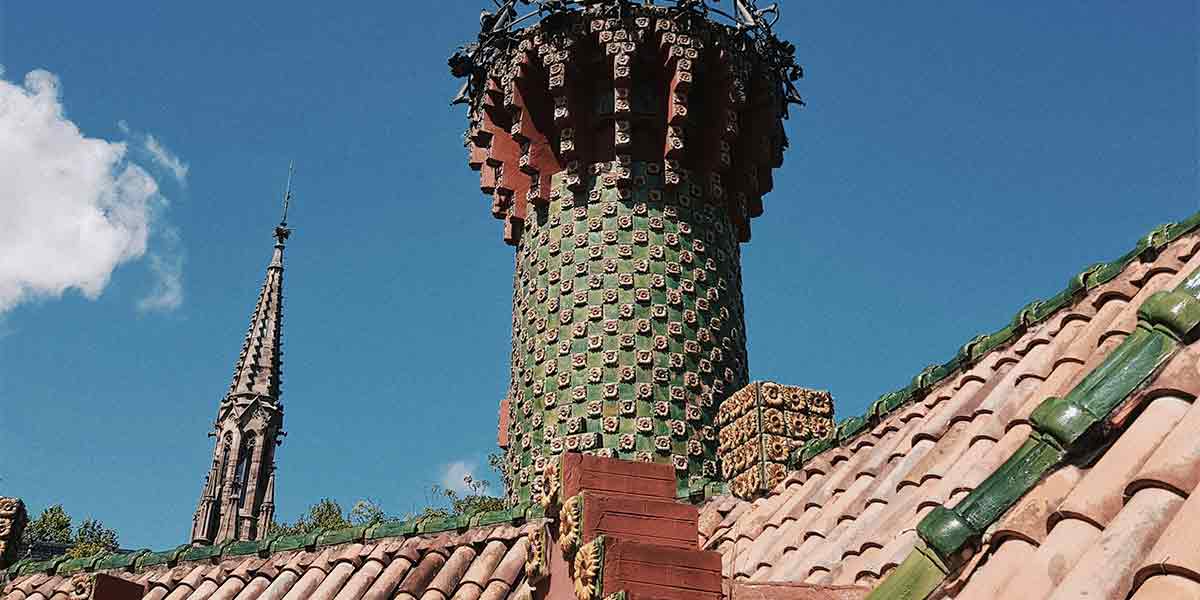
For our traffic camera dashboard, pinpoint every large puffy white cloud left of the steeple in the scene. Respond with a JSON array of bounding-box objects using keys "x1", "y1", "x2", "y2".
[{"x1": 0, "y1": 71, "x2": 181, "y2": 314}]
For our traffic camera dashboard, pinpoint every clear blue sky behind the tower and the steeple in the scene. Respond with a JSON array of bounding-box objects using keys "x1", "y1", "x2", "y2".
[{"x1": 0, "y1": 0, "x2": 1200, "y2": 548}]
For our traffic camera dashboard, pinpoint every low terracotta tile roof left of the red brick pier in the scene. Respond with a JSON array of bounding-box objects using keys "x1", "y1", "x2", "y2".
[{"x1": 0, "y1": 518, "x2": 544, "y2": 600}]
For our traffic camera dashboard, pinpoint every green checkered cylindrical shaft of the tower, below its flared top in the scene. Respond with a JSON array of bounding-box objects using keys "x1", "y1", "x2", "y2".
[{"x1": 508, "y1": 161, "x2": 748, "y2": 500}]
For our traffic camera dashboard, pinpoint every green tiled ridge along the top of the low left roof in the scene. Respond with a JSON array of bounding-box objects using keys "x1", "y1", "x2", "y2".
[{"x1": 6, "y1": 503, "x2": 545, "y2": 581}]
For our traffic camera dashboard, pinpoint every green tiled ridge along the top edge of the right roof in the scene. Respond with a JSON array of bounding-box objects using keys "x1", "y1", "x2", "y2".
[{"x1": 790, "y1": 211, "x2": 1200, "y2": 470}]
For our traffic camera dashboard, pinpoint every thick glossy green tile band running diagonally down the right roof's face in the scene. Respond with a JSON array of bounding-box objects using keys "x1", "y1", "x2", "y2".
[{"x1": 872, "y1": 256, "x2": 1200, "y2": 598}]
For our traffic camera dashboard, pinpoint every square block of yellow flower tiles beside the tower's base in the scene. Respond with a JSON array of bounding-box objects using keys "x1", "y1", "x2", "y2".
[{"x1": 716, "y1": 382, "x2": 833, "y2": 498}]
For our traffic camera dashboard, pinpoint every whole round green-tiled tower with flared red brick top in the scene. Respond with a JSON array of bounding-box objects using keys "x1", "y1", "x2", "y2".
[{"x1": 451, "y1": 0, "x2": 799, "y2": 500}]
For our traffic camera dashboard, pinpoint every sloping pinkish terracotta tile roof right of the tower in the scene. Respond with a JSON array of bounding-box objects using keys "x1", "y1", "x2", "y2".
[{"x1": 701, "y1": 216, "x2": 1200, "y2": 600}]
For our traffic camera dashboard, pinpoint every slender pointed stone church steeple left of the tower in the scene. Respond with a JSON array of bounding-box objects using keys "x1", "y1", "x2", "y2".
[{"x1": 191, "y1": 167, "x2": 292, "y2": 545}]
